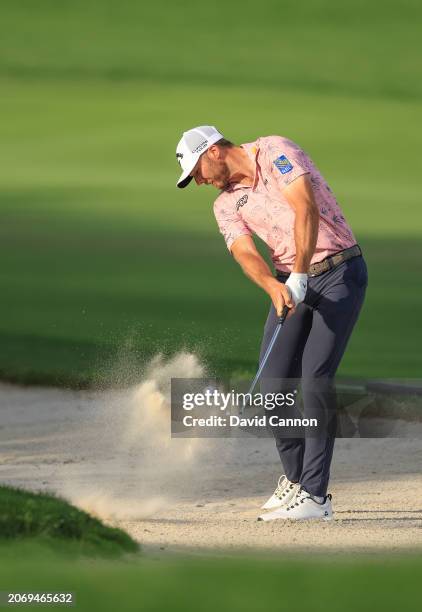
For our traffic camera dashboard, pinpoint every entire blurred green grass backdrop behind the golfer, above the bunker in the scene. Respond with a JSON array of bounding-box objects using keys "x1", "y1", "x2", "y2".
[{"x1": 0, "y1": 0, "x2": 422, "y2": 385}]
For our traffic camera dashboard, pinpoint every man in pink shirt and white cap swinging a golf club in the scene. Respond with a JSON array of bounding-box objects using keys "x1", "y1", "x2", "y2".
[{"x1": 176, "y1": 126, "x2": 368, "y2": 521}]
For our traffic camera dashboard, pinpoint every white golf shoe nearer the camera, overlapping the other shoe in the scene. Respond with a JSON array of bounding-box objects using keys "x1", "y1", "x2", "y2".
[{"x1": 258, "y1": 489, "x2": 333, "y2": 521}]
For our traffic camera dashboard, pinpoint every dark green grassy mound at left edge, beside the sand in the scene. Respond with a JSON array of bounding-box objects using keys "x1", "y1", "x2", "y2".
[{"x1": 0, "y1": 486, "x2": 139, "y2": 556}]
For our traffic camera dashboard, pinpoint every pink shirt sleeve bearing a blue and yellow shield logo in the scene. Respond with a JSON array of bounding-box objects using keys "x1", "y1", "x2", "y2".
[{"x1": 266, "y1": 136, "x2": 311, "y2": 191}]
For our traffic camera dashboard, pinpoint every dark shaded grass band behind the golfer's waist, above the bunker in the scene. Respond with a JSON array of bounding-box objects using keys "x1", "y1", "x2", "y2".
[{"x1": 0, "y1": 233, "x2": 422, "y2": 387}]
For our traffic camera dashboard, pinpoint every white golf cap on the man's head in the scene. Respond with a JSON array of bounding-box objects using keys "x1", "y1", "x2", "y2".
[{"x1": 176, "y1": 125, "x2": 224, "y2": 188}]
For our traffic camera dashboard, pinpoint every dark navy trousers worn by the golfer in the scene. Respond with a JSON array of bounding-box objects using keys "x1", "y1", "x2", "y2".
[{"x1": 260, "y1": 256, "x2": 368, "y2": 497}]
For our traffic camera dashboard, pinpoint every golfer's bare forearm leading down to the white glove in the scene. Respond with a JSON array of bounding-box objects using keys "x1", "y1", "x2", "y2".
[{"x1": 293, "y1": 204, "x2": 319, "y2": 273}]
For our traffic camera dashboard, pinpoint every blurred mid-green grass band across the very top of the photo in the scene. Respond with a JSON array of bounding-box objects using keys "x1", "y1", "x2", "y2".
[{"x1": 0, "y1": 0, "x2": 422, "y2": 100}]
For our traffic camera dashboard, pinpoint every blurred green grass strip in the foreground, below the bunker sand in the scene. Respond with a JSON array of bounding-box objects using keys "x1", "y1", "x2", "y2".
[{"x1": 0, "y1": 547, "x2": 422, "y2": 612}]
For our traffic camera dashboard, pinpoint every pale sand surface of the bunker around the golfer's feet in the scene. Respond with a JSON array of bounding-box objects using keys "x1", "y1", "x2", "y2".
[{"x1": 0, "y1": 372, "x2": 422, "y2": 554}]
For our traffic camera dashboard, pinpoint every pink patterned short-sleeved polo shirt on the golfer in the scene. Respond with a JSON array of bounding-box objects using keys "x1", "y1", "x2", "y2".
[{"x1": 214, "y1": 136, "x2": 356, "y2": 272}]
